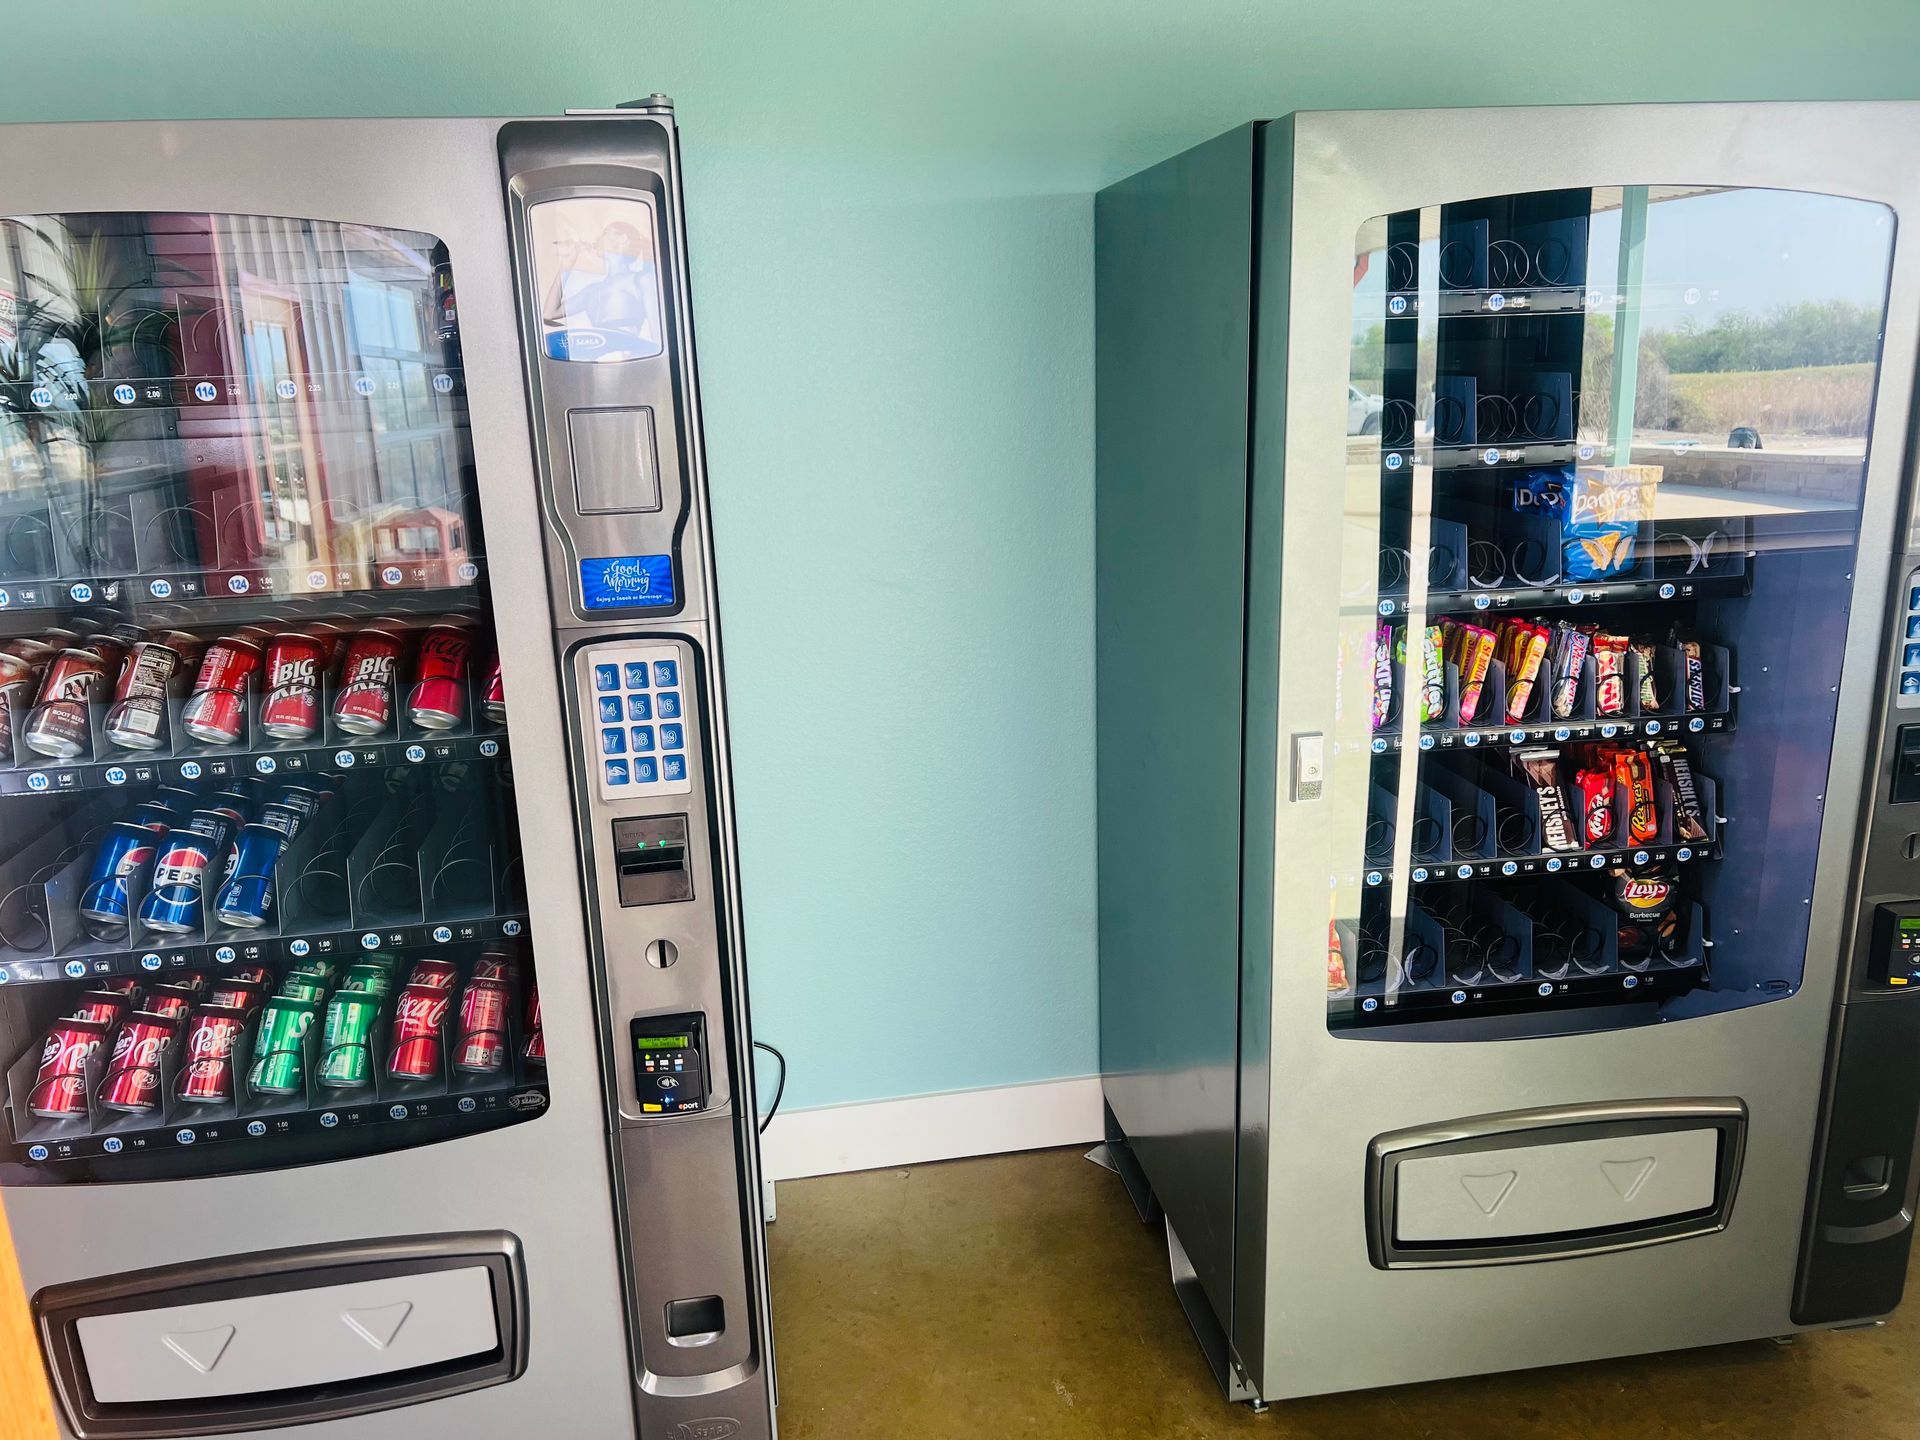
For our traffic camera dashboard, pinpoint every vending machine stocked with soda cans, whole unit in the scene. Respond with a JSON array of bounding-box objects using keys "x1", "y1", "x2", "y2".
[{"x1": 0, "y1": 98, "x2": 772, "y2": 1440}]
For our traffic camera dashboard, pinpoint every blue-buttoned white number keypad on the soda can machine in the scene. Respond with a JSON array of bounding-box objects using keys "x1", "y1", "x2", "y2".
[{"x1": 584, "y1": 643, "x2": 693, "y2": 801}]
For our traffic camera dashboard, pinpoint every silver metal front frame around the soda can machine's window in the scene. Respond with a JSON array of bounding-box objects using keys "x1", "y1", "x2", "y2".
[{"x1": 0, "y1": 119, "x2": 634, "y2": 1440}]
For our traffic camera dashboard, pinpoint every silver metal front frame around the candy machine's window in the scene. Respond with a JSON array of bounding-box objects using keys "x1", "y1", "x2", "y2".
[{"x1": 1248, "y1": 104, "x2": 1920, "y2": 1398}]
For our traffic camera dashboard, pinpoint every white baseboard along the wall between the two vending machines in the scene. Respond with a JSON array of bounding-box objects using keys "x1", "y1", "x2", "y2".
[{"x1": 760, "y1": 1075, "x2": 1102, "y2": 1181}]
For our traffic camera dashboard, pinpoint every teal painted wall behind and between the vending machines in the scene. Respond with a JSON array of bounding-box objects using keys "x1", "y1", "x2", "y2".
[{"x1": 0, "y1": 0, "x2": 1920, "y2": 1106}]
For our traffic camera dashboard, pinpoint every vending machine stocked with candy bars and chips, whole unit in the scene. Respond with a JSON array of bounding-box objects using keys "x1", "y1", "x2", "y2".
[{"x1": 1096, "y1": 104, "x2": 1920, "y2": 1402}]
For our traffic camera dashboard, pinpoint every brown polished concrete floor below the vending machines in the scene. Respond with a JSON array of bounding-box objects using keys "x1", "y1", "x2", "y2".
[{"x1": 772, "y1": 1150, "x2": 1920, "y2": 1440}]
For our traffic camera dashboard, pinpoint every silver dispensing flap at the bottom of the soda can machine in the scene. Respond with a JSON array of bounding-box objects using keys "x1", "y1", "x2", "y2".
[{"x1": 75, "y1": 1265, "x2": 499, "y2": 1405}]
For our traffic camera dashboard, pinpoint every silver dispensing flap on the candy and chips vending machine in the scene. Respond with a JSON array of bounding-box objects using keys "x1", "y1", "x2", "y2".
[{"x1": 1394, "y1": 1129, "x2": 1720, "y2": 1242}]
